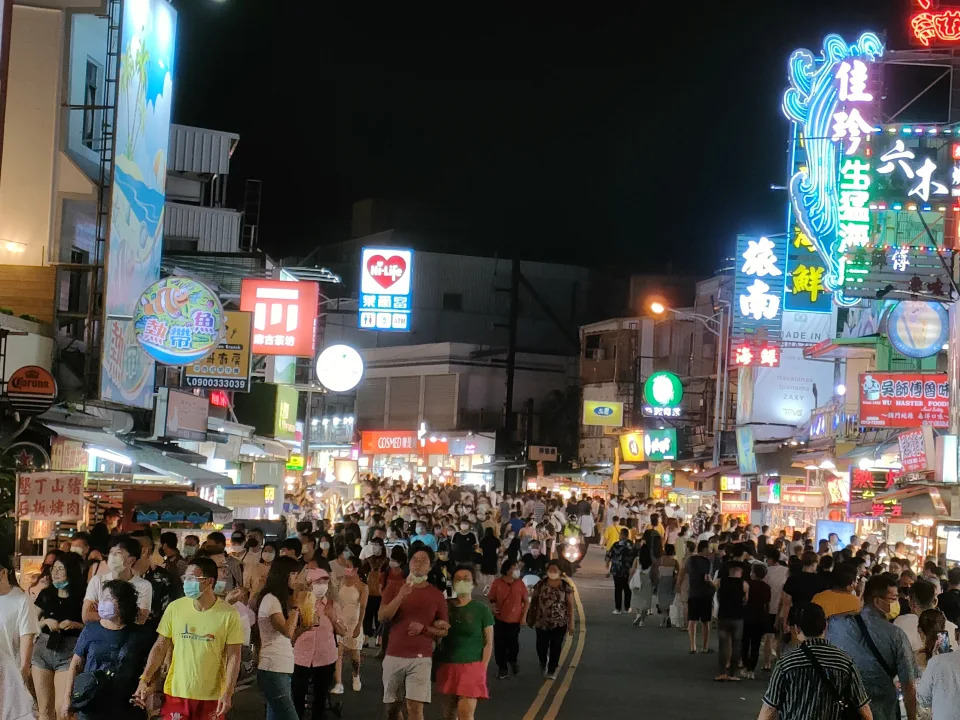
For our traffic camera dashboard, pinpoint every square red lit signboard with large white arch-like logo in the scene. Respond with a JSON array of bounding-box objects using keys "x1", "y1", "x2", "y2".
[{"x1": 240, "y1": 278, "x2": 320, "y2": 357}]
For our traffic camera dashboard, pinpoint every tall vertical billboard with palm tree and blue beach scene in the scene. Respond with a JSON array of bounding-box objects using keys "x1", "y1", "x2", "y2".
[{"x1": 100, "y1": 0, "x2": 177, "y2": 408}]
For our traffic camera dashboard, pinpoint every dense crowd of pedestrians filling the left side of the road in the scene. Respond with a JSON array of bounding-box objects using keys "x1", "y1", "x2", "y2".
[{"x1": 0, "y1": 478, "x2": 612, "y2": 720}]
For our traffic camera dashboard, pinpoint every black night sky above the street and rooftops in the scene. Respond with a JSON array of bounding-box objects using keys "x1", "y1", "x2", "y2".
[{"x1": 174, "y1": 0, "x2": 936, "y2": 273}]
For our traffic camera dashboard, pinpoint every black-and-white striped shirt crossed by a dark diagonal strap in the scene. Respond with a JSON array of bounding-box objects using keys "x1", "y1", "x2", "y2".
[{"x1": 763, "y1": 638, "x2": 870, "y2": 720}]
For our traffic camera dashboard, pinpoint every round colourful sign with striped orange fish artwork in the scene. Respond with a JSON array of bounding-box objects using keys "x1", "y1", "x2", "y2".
[{"x1": 133, "y1": 277, "x2": 224, "y2": 365}]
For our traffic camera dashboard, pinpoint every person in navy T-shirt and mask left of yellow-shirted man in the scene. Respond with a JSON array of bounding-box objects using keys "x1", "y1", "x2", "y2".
[{"x1": 57, "y1": 580, "x2": 151, "y2": 720}]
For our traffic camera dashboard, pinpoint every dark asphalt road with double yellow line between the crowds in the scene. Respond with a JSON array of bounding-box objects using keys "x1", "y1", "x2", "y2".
[{"x1": 231, "y1": 546, "x2": 768, "y2": 720}]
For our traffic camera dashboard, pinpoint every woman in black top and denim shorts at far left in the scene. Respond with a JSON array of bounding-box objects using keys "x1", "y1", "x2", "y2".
[{"x1": 33, "y1": 552, "x2": 87, "y2": 720}]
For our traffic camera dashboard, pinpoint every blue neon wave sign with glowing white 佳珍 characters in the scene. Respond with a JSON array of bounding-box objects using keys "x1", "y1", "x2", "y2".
[{"x1": 782, "y1": 33, "x2": 883, "y2": 307}]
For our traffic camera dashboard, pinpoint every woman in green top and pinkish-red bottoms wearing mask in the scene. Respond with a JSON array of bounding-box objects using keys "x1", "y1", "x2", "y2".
[{"x1": 437, "y1": 565, "x2": 493, "y2": 720}]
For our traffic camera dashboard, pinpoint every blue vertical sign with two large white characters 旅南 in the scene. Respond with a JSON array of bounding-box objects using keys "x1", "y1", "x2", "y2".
[{"x1": 731, "y1": 235, "x2": 787, "y2": 338}]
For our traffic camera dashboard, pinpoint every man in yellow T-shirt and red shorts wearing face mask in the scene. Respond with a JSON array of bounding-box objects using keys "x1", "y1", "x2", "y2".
[{"x1": 134, "y1": 557, "x2": 243, "y2": 720}]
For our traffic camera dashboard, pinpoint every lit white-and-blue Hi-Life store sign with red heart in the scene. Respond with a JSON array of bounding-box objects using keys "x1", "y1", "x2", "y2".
[{"x1": 359, "y1": 247, "x2": 413, "y2": 332}]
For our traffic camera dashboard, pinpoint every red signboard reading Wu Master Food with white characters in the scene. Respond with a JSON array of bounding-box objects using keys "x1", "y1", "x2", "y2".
[{"x1": 860, "y1": 372, "x2": 950, "y2": 428}]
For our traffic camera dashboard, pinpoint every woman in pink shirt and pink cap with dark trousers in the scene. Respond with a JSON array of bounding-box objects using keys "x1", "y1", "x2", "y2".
[{"x1": 292, "y1": 568, "x2": 346, "y2": 720}]
